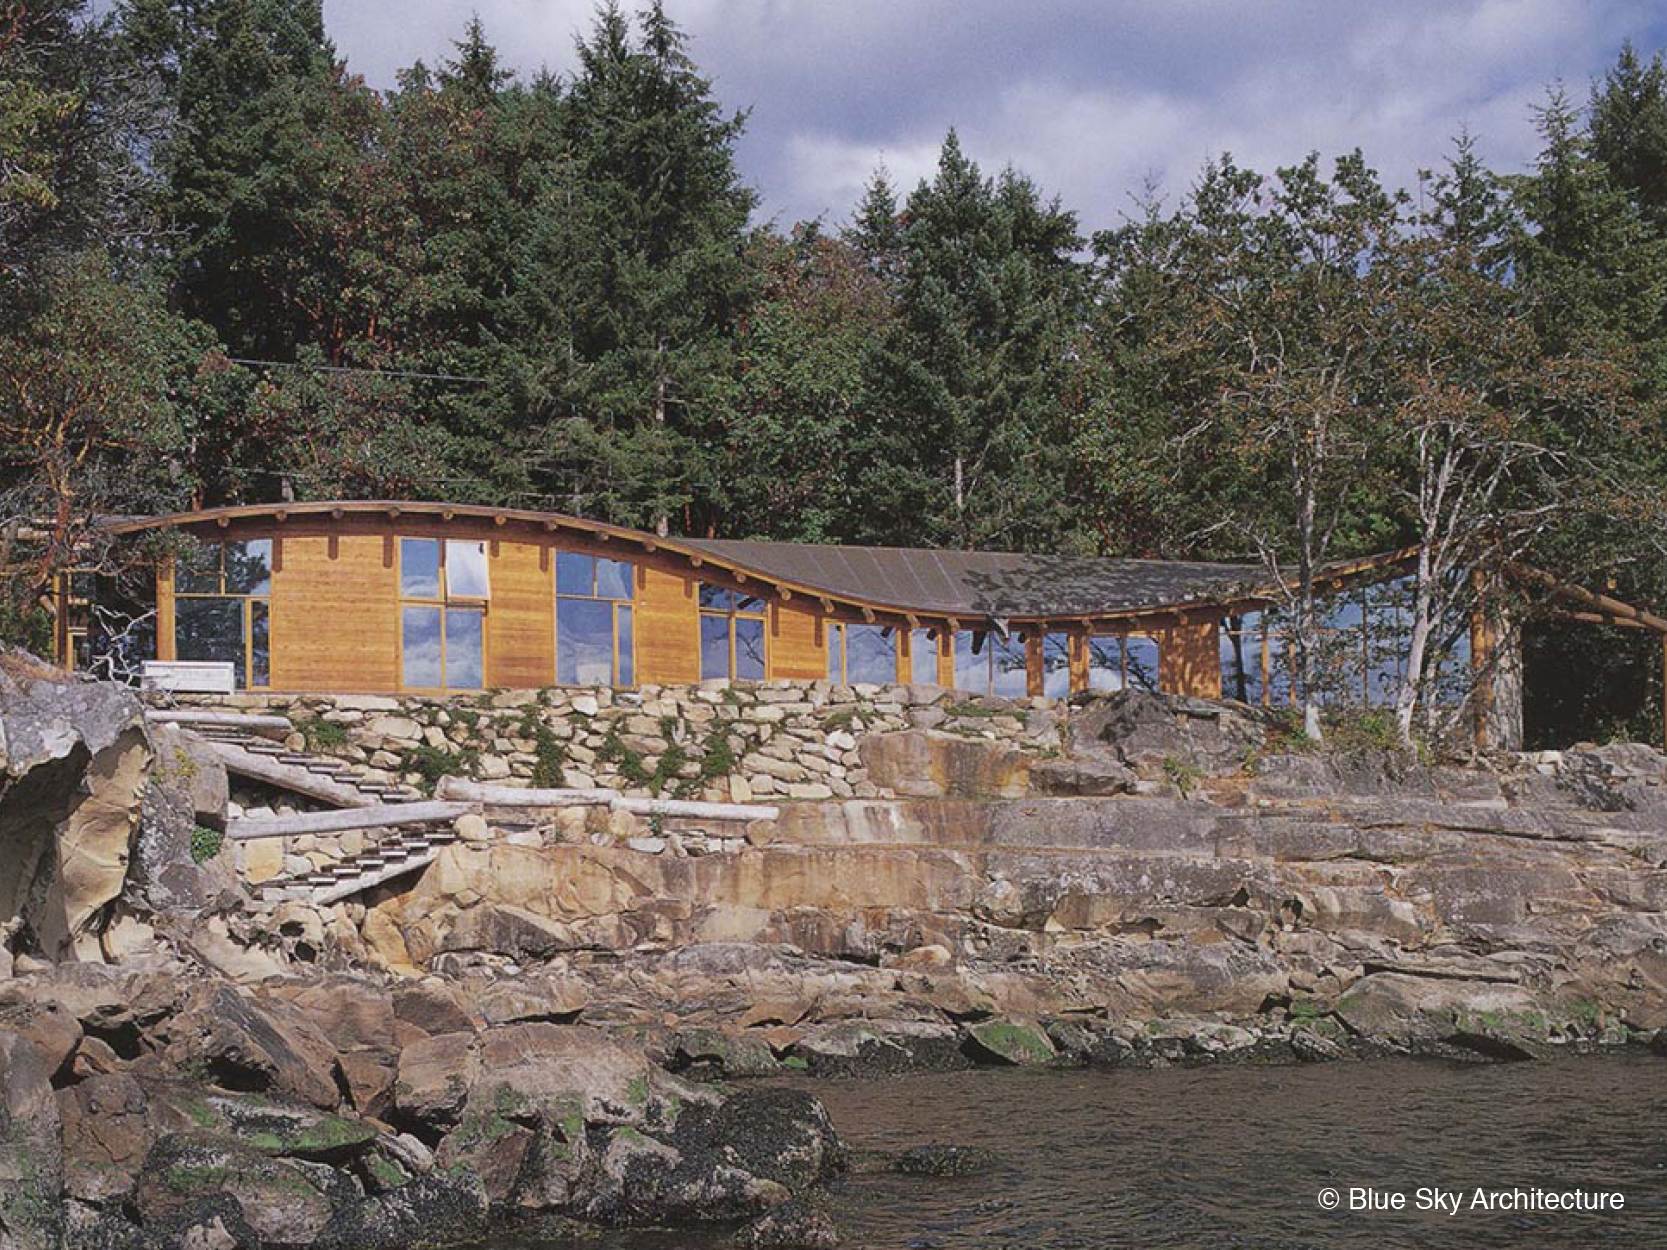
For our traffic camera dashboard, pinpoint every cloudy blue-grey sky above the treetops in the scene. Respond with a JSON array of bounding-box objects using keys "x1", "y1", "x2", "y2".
[{"x1": 325, "y1": 0, "x2": 1667, "y2": 228}]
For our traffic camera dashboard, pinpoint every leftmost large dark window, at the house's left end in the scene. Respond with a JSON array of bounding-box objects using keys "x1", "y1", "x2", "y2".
[{"x1": 173, "y1": 538, "x2": 272, "y2": 690}]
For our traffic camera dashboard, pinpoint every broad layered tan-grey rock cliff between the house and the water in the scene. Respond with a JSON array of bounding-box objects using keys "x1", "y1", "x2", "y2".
[{"x1": 355, "y1": 695, "x2": 1667, "y2": 1062}]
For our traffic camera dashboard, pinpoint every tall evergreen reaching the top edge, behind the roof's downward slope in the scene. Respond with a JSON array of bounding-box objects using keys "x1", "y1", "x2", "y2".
[{"x1": 543, "y1": 3, "x2": 755, "y2": 532}]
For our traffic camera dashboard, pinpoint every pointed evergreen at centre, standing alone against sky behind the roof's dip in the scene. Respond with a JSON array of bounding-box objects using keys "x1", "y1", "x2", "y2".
[{"x1": 855, "y1": 132, "x2": 1084, "y2": 548}]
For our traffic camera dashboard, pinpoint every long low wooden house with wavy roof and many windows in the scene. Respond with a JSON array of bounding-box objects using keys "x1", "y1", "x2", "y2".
[{"x1": 81, "y1": 502, "x2": 1667, "y2": 753}]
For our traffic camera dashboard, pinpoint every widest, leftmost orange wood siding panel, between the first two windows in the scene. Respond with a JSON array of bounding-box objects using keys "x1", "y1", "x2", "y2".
[{"x1": 276, "y1": 533, "x2": 400, "y2": 692}]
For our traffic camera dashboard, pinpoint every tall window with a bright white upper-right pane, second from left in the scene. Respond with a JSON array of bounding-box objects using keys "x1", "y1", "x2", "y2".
[{"x1": 400, "y1": 538, "x2": 492, "y2": 690}]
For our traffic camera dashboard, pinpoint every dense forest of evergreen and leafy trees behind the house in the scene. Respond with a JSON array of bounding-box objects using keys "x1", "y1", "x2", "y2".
[{"x1": 0, "y1": 0, "x2": 1667, "y2": 740}]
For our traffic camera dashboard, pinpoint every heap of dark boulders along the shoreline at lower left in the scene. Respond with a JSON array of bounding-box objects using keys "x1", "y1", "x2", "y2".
[{"x1": 0, "y1": 965, "x2": 842, "y2": 1250}]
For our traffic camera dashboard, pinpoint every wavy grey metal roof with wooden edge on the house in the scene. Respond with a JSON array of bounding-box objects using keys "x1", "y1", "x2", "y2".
[{"x1": 105, "y1": 500, "x2": 1399, "y2": 620}]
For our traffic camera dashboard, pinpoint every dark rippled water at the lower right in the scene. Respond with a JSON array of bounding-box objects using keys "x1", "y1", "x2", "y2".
[{"x1": 517, "y1": 1055, "x2": 1667, "y2": 1250}]
